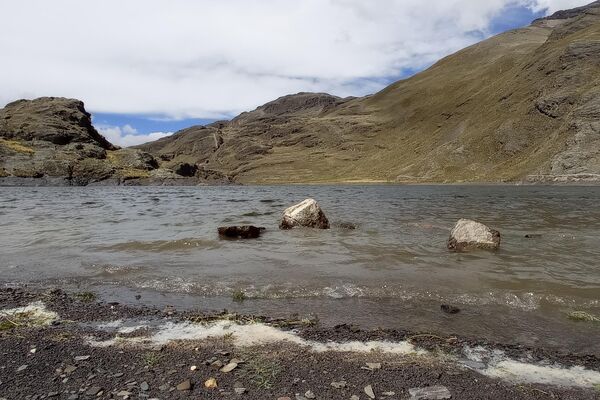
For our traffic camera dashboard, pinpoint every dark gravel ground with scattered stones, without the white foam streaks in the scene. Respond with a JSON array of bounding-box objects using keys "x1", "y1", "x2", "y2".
[{"x1": 0, "y1": 288, "x2": 600, "y2": 400}]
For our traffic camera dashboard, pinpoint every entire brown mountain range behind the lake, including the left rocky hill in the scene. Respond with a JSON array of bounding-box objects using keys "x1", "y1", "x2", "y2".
[{"x1": 0, "y1": 1, "x2": 600, "y2": 185}]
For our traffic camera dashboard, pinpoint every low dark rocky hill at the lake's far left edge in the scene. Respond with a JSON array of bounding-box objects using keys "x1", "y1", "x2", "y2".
[{"x1": 0, "y1": 97, "x2": 231, "y2": 185}]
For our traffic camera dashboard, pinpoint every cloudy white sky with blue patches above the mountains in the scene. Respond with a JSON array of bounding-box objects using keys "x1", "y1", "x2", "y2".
[{"x1": 0, "y1": 0, "x2": 592, "y2": 146}]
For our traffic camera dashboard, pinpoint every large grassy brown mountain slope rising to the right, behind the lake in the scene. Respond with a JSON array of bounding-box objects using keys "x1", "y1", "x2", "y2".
[{"x1": 138, "y1": 2, "x2": 600, "y2": 183}]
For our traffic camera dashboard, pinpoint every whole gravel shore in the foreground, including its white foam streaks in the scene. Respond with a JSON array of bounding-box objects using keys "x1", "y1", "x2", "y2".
[{"x1": 0, "y1": 288, "x2": 600, "y2": 400}]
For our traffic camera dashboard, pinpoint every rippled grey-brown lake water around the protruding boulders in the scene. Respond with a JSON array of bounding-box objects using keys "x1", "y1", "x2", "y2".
[{"x1": 0, "y1": 185, "x2": 600, "y2": 354}]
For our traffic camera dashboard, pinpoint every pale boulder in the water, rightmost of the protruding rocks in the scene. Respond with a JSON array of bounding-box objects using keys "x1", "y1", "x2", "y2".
[{"x1": 448, "y1": 219, "x2": 500, "y2": 251}]
